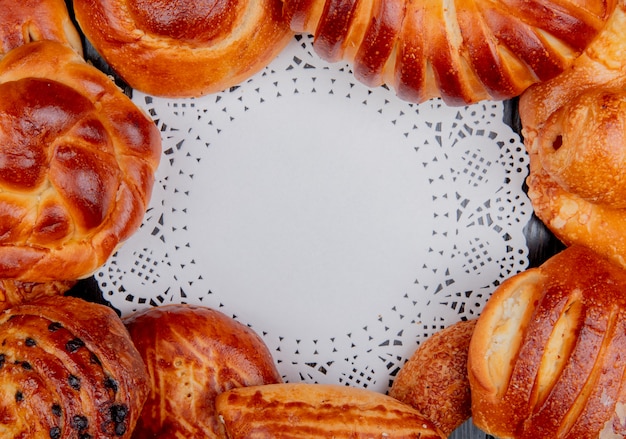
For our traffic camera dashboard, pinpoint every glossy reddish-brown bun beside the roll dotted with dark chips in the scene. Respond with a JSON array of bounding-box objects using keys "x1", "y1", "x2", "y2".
[{"x1": 124, "y1": 305, "x2": 282, "y2": 439}]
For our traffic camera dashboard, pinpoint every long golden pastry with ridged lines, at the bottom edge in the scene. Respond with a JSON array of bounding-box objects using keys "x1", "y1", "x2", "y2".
[{"x1": 216, "y1": 383, "x2": 446, "y2": 439}]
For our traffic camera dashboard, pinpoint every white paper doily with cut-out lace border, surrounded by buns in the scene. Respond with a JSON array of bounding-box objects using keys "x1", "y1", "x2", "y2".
[{"x1": 96, "y1": 34, "x2": 532, "y2": 391}]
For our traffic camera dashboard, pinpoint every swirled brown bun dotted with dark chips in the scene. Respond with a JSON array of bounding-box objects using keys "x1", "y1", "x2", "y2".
[{"x1": 0, "y1": 296, "x2": 148, "y2": 439}]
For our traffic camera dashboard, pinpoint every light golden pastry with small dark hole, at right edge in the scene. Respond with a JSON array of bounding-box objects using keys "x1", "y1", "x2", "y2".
[{"x1": 519, "y1": 2, "x2": 626, "y2": 267}]
